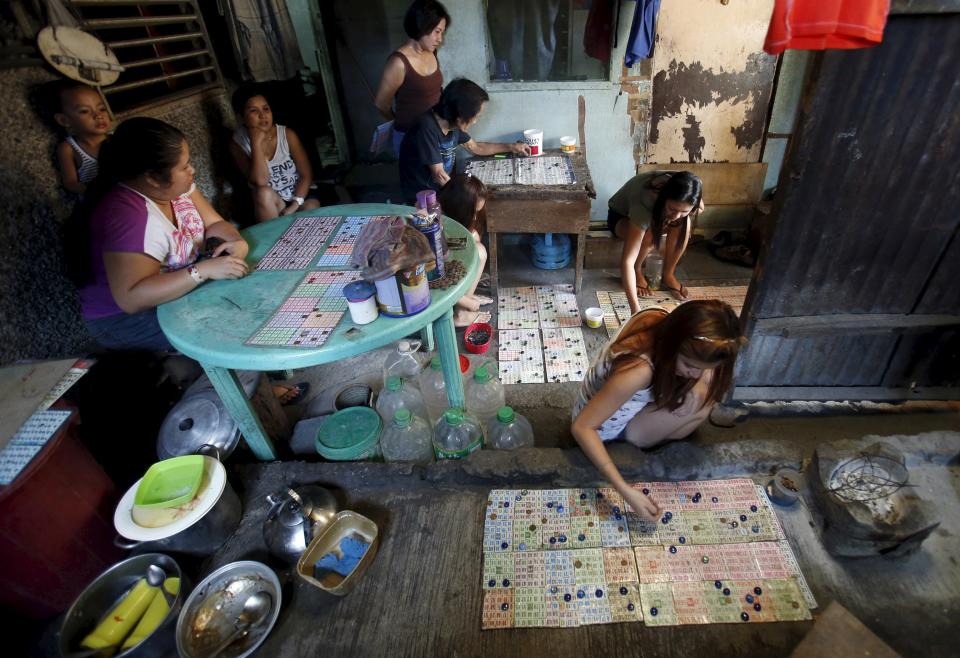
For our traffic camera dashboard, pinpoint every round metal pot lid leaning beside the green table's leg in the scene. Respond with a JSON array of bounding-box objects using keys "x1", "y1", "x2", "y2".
[{"x1": 157, "y1": 390, "x2": 240, "y2": 459}]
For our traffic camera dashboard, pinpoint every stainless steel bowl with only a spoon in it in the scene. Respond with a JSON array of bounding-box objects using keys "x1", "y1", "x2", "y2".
[{"x1": 177, "y1": 560, "x2": 281, "y2": 658}]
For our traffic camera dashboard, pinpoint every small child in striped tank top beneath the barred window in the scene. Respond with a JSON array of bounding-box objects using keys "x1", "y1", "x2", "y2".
[{"x1": 51, "y1": 80, "x2": 112, "y2": 194}]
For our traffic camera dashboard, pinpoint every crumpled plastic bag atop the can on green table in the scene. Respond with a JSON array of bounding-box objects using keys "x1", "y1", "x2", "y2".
[{"x1": 350, "y1": 215, "x2": 435, "y2": 281}]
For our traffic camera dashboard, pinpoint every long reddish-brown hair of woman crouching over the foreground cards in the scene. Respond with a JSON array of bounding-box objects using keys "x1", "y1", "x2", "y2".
[{"x1": 610, "y1": 299, "x2": 746, "y2": 411}]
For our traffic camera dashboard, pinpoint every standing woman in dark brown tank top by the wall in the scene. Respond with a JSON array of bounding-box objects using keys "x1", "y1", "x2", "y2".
[{"x1": 374, "y1": 0, "x2": 450, "y2": 154}]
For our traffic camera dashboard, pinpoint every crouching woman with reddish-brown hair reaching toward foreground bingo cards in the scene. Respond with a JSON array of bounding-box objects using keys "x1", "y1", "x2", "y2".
[{"x1": 571, "y1": 300, "x2": 744, "y2": 520}]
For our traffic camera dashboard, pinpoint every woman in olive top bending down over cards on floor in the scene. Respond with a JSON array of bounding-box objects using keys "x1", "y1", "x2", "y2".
[{"x1": 607, "y1": 171, "x2": 704, "y2": 313}]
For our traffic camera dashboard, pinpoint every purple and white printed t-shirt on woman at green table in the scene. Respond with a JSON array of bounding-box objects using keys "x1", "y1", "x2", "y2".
[{"x1": 80, "y1": 184, "x2": 203, "y2": 320}]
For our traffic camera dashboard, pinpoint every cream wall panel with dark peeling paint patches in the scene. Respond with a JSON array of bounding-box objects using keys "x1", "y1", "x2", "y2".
[{"x1": 646, "y1": 0, "x2": 777, "y2": 163}]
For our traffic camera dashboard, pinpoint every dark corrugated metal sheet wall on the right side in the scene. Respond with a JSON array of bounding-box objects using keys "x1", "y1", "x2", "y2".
[{"x1": 736, "y1": 14, "x2": 960, "y2": 394}]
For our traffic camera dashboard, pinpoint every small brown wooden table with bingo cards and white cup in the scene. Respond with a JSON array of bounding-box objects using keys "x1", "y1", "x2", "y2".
[{"x1": 478, "y1": 149, "x2": 597, "y2": 293}]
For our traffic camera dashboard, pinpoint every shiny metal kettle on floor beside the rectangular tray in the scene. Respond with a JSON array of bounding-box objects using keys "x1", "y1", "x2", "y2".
[{"x1": 263, "y1": 484, "x2": 338, "y2": 564}]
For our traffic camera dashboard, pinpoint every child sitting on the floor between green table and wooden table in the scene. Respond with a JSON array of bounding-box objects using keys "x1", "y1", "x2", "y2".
[{"x1": 437, "y1": 174, "x2": 493, "y2": 327}]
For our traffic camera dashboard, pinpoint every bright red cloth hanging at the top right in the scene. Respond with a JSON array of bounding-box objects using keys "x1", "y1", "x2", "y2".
[{"x1": 763, "y1": 0, "x2": 890, "y2": 55}]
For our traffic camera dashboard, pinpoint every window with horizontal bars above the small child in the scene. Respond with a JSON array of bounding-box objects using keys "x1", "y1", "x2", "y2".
[{"x1": 70, "y1": 0, "x2": 223, "y2": 112}]
